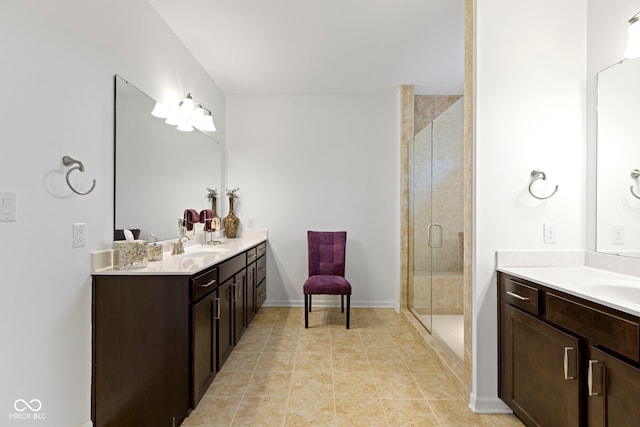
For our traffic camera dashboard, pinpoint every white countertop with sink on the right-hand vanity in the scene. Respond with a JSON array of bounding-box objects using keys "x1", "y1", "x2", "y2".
[{"x1": 497, "y1": 253, "x2": 640, "y2": 317}]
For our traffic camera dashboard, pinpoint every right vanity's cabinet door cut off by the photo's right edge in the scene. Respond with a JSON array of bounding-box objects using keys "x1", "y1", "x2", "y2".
[{"x1": 587, "y1": 347, "x2": 640, "y2": 427}]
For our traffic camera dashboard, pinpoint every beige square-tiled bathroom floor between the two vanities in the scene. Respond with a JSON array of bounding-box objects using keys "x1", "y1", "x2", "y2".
[{"x1": 182, "y1": 307, "x2": 522, "y2": 427}]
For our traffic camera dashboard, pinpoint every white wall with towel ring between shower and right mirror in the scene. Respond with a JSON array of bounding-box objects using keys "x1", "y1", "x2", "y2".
[{"x1": 471, "y1": 0, "x2": 587, "y2": 411}]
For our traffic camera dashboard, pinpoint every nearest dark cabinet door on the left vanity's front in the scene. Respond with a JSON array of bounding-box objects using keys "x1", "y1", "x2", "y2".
[{"x1": 191, "y1": 292, "x2": 217, "y2": 408}]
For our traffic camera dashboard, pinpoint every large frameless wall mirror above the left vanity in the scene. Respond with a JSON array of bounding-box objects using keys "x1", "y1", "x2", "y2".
[{"x1": 114, "y1": 76, "x2": 222, "y2": 240}]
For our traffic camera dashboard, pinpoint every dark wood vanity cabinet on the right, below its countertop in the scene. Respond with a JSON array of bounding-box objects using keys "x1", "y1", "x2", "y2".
[{"x1": 498, "y1": 273, "x2": 640, "y2": 427}]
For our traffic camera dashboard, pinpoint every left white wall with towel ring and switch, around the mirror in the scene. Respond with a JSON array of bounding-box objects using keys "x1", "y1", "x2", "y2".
[{"x1": 0, "y1": 0, "x2": 225, "y2": 427}]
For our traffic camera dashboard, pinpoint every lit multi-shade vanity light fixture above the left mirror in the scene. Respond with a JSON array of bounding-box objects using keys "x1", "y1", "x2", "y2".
[{"x1": 151, "y1": 93, "x2": 216, "y2": 132}]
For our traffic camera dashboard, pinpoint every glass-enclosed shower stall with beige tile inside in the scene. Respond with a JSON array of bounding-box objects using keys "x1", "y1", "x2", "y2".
[{"x1": 407, "y1": 97, "x2": 464, "y2": 363}]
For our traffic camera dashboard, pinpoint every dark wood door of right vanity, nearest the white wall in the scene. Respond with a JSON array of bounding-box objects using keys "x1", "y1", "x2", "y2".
[{"x1": 501, "y1": 305, "x2": 581, "y2": 427}]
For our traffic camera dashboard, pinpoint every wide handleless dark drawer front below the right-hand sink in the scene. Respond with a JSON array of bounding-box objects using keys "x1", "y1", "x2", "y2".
[{"x1": 545, "y1": 292, "x2": 640, "y2": 362}]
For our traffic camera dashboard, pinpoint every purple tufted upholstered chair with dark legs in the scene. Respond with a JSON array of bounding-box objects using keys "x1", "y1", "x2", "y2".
[{"x1": 303, "y1": 231, "x2": 351, "y2": 329}]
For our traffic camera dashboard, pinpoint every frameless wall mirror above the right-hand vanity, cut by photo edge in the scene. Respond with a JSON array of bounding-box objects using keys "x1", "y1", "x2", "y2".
[{"x1": 596, "y1": 59, "x2": 640, "y2": 258}]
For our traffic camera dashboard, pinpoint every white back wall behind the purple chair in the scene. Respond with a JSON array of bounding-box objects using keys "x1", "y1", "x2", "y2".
[{"x1": 226, "y1": 90, "x2": 400, "y2": 307}]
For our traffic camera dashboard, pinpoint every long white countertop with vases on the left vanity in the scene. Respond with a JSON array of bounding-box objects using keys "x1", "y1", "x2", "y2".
[{"x1": 92, "y1": 230, "x2": 267, "y2": 275}]
